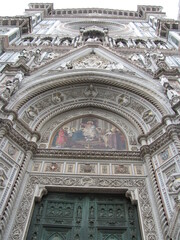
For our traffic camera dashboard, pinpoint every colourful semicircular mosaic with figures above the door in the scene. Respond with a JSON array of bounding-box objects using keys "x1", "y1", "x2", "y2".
[{"x1": 51, "y1": 117, "x2": 127, "y2": 150}]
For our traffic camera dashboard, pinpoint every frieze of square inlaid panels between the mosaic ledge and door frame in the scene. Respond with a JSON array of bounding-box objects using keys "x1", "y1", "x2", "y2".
[{"x1": 31, "y1": 159, "x2": 144, "y2": 176}]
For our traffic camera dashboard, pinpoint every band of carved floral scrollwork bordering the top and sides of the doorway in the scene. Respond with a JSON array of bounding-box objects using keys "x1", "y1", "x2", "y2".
[{"x1": 9, "y1": 176, "x2": 158, "y2": 240}]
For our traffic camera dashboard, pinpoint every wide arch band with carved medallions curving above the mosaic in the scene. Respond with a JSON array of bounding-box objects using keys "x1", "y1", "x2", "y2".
[{"x1": 14, "y1": 79, "x2": 162, "y2": 134}]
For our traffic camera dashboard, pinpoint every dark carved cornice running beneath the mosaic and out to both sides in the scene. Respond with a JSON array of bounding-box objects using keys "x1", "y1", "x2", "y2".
[{"x1": 0, "y1": 119, "x2": 180, "y2": 158}]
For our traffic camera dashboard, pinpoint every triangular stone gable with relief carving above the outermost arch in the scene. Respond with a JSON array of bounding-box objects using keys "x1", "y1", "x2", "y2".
[{"x1": 30, "y1": 44, "x2": 149, "y2": 78}]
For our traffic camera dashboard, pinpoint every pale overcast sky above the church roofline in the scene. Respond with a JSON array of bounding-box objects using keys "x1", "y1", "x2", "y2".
[{"x1": 0, "y1": 0, "x2": 179, "y2": 19}]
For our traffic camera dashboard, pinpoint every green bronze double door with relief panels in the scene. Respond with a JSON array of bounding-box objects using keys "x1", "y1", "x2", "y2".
[{"x1": 27, "y1": 193, "x2": 141, "y2": 240}]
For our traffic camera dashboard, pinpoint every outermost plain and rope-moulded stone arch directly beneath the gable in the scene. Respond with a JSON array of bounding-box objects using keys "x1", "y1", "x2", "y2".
[{"x1": 7, "y1": 71, "x2": 170, "y2": 116}]
